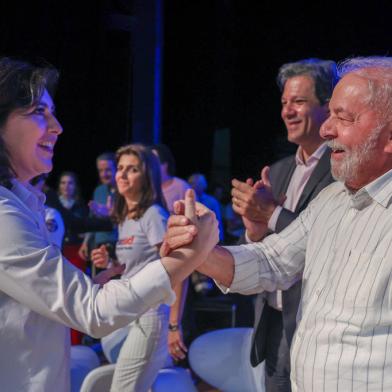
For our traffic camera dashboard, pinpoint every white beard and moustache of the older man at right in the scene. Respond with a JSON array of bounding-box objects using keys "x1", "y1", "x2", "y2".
[{"x1": 327, "y1": 126, "x2": 383, "y2": 183}]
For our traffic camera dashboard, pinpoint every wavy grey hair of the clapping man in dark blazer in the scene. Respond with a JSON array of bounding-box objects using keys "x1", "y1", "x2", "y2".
[{"x1": 277, "y1": 58, "x2": 338, "y2": 105}]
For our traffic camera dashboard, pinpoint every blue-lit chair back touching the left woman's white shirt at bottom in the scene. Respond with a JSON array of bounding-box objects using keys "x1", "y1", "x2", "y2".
[{"x1": 71, "y1": 346, "x2": 100, "y2": 392}]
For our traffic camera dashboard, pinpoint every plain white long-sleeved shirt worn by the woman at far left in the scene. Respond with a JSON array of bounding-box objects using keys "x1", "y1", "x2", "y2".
[{"x1": 0, "y1": 181, "x2": 174, "y2": 392}]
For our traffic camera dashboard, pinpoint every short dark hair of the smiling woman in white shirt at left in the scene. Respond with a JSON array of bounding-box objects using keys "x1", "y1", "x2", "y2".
[{"x1": 0, "y1": 57, "x2": 58, "y2": 188}]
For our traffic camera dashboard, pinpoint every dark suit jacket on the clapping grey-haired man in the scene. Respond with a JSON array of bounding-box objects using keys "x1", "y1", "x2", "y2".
[{"x1": 251, "y1": 149, "x2": 334, "y2": 366}]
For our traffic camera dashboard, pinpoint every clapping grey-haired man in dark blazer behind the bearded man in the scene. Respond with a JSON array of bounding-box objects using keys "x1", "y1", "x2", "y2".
[{"x1": 232, "y1": 59, "x2": 336, "y2": 392}]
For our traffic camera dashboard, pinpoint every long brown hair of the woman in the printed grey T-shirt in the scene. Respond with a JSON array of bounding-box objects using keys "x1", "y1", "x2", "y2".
[{"x1": 113, "y1": 144, "x2": 167, "y2": 223}]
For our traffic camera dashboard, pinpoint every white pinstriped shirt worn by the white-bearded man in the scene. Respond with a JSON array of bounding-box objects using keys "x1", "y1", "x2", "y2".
[{"x1": 222, "y1": 170, "x2": 392, "y2": 392}]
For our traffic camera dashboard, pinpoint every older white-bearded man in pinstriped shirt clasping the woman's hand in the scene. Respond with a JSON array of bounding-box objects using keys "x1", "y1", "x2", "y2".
[{"x1": 162, "y1": 58, "x2": 392, "y2": 392}]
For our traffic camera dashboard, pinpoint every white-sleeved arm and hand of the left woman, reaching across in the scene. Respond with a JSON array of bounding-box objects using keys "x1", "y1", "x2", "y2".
[{"x1": 0, "y1": 190, "x2": 218, "y2": 337}]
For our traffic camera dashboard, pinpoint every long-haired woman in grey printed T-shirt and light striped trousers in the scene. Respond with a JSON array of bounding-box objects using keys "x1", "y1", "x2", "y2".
[{"x1": 92, "y1": 144, "x2": 169, "y2": 392}]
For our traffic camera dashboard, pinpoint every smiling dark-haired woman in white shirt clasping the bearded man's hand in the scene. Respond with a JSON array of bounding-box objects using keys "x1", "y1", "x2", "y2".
[{"x1": 0, "y1": 58, "x2": 218, "y2": 392}]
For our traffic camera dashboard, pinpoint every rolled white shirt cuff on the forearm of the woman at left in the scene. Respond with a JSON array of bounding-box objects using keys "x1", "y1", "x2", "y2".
[{"x1": 131, "y1": 260, "x2": 176, "y2": 307}]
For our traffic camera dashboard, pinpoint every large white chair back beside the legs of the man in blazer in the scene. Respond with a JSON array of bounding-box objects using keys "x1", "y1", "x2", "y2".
[{"x1": 189, "y1": 328, "x2": 264, "y2": 392}]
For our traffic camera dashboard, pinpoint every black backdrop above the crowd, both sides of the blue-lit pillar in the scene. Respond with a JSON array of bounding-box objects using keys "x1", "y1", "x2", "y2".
[{"x1": 0, "y1": 0, "x2": 391, "y2": 198}]
